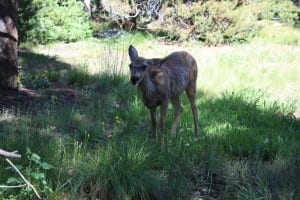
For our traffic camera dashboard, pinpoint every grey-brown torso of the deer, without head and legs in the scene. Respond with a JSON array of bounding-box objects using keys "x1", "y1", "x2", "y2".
[{"x1": 139, "y1": 52, "x2": 197, "y2": 108}]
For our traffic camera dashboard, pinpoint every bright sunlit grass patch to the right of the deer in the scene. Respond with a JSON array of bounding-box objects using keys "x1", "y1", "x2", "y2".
[{"x1": 196, "y1": 44, "x2": 300, "y2": 106}]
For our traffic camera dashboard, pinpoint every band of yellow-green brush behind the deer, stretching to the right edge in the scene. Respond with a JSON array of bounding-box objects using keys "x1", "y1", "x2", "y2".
[{"x1": 148, "y1": 0, "x2": 299, "y2": 45}]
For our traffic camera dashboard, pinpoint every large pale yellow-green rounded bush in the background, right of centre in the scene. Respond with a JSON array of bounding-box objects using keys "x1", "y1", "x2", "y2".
[{"x1": 146, "y1": 1, "x2": 258, "y2": 45}]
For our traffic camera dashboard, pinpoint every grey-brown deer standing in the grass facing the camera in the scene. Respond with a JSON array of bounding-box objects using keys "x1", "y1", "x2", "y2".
[{"x1": 128, "y1": 45, "x2": 198, "y2": 140}]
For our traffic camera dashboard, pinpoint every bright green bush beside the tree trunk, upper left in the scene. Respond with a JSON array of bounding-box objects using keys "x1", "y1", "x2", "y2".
[{"x1": 19, "y1": 0, "x2": 92, "y2": 44}]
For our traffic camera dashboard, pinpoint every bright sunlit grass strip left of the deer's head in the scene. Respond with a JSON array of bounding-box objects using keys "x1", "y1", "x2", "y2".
[{"x1": 29, "y1": 33, "x2": 154, "y2": 74}]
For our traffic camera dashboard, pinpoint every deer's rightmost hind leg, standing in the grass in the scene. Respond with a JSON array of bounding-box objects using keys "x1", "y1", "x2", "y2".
[{"x1": 185, "y1": 81, "x2": 198, "y2": 135}]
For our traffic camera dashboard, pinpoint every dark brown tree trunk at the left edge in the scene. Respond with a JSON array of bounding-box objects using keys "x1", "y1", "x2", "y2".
[{"x1": 0, "y1": 0, "x2": 18, "y2": 89}]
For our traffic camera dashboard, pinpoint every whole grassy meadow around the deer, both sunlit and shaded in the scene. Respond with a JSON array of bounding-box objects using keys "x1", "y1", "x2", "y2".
[{"x1": 0, "y1": 30, "x2": 300, "y2": 199}]
